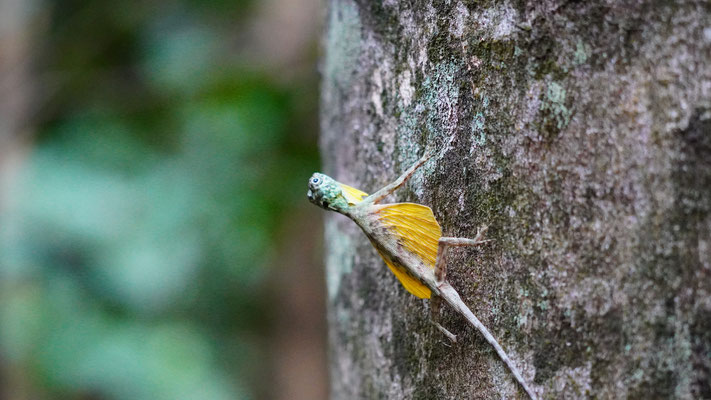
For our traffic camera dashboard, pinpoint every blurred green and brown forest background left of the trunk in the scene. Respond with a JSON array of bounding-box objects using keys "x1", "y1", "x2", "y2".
[{"x1": 0, "y1": 0, "x2": 327, "y2": 400}]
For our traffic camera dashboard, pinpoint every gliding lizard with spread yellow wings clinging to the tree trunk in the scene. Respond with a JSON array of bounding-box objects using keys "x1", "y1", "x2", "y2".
[{"x1": 307, "y1": 152, "x2": 536, "y2": 400}]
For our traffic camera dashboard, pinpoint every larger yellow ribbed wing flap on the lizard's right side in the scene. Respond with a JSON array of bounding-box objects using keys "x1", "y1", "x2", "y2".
[{"x1": 373, "y1": 203, "x2": 442, "y2": 268}]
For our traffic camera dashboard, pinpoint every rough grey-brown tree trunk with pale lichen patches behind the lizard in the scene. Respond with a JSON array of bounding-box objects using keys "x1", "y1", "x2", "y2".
[{"x1": 321, "y1": 0, "x2": 711, "y2": 399}]
